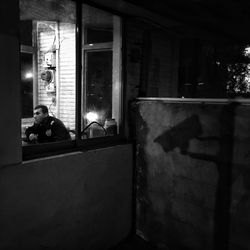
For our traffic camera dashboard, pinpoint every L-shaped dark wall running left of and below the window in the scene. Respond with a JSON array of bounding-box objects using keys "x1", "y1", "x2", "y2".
[{"x1": 0, "y1": 0, "x2": 132, "y2": 250}]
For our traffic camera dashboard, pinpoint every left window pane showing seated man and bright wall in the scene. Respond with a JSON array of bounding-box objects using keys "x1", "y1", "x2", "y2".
[{"x1": 19, "y1": 0, "x2": 76, "y2": 144}]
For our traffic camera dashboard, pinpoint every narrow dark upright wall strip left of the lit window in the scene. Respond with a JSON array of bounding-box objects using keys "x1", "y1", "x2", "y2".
[{"x1": 0, "y1": 0, "x2": 21, "y2": 166}]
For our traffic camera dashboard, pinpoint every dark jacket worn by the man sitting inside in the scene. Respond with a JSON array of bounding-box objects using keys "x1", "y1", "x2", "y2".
[{"x1": 25, "y1": 116, "x2": 71, "y2": 143}]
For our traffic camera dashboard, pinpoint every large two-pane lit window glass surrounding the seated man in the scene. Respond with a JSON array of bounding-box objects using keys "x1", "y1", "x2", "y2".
[{"x1": 19, "y1": 0, "x2": 122, "y2": 156}]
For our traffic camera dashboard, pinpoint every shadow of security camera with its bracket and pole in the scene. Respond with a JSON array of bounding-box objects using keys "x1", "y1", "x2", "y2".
[{"x1": 154, "y1": 103, "x2": 237, "y2": 250}]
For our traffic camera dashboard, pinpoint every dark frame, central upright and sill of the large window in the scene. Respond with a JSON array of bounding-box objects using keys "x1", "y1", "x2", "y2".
[{"x1": 20, "y1": 0, "x2": 127, "y2": 161}]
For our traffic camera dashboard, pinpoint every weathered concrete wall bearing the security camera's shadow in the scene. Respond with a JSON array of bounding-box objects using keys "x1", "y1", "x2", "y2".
[{"x1": 134, "y1": 99, "x2": 250, "y2": 250}]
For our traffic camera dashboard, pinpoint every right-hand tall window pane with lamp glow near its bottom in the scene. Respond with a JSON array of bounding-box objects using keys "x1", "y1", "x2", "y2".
[{"x1": 82, "y1": 4, "x2": 121, "y2": 138}]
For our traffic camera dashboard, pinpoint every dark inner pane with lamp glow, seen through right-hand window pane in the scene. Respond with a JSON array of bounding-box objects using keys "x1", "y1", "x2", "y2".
[{"x1": 84, "y1": 50, "x2": 113, "y2": 138}]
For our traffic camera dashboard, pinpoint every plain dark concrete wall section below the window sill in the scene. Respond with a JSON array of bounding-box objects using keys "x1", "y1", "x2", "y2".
[{"x1": 0, "y1": 145, "x2": 132, "y2": 250}]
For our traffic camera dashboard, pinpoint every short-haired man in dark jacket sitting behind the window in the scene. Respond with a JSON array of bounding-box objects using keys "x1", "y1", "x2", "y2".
[{"x1": 25, "y1": 105, "x2": 70, "y2": 143}]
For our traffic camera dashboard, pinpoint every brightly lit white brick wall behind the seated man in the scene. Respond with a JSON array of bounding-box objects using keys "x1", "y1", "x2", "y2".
[{"x1": 36, "y1": 22, "x2": 75, "y2": 129}]
